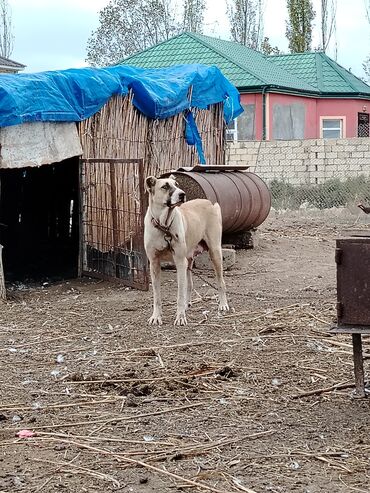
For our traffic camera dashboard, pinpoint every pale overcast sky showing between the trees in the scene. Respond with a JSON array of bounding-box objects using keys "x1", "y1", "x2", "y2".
[{"x1": 9, "y1": 0, "x2": 370, "y2": 80}]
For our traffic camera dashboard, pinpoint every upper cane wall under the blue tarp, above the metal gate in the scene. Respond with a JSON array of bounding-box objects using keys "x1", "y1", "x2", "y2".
[{"x1": 79, "y1": 94, "x2": 225, "y2": 171}]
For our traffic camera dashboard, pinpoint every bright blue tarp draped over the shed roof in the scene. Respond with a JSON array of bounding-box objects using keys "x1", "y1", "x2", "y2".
[{"x1": 0, "y1": 64, "x2": 243, "y2": 127}]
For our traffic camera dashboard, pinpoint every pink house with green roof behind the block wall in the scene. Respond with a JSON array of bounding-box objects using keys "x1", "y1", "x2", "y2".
[{"x1": 120, "y1": 33, "x2": 370, "y2": 140}]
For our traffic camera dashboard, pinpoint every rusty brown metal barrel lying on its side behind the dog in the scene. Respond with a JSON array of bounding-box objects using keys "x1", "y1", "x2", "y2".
[{"x1": 162, "y1": 166, "x2": 271, "y2": 233}]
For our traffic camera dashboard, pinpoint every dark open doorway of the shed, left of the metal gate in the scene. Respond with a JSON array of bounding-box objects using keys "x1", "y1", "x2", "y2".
[{"x1": 0, "y1": 157, "x2": 79, "y2": 282}]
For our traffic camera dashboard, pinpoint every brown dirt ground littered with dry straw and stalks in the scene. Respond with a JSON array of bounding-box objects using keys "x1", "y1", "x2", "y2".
[{"x1": 0, "y1": 209, "x2": 370, "y2": 493}]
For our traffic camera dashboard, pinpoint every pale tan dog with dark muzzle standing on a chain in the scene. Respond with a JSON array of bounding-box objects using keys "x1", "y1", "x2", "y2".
[{"x1": 144, "y1": 175, "x2": 229, "y2": 325}]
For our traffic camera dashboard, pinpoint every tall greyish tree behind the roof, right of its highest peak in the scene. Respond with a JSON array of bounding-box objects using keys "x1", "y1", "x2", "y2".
[{"x1": 227, "y1": 0, "x2": 264, "y2": 50}]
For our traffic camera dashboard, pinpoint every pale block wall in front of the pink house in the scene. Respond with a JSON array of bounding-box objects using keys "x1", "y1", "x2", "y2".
[{"x1": 226, "y1": 138, "x2": 370, "y2": 185}]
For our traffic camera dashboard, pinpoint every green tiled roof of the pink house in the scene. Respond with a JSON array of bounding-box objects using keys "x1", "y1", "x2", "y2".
[{"x1": 119, "y1": 33, "x2": 370, "y2": 97}]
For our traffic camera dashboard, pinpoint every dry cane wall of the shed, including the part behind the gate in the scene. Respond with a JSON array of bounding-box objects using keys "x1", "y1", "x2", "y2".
[{"x1": 79, "y1": 94, "x2": 225, "y2": 251}]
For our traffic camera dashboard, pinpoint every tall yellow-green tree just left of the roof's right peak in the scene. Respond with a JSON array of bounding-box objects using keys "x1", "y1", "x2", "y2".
[{"x1": 286, "y1": 0, "x2": 315, "y2": 53}]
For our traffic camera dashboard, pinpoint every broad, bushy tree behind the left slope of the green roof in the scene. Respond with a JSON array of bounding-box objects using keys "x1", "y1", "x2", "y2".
[{"x1": 86, "y1": 0, "x2": 179, "y2": 66}]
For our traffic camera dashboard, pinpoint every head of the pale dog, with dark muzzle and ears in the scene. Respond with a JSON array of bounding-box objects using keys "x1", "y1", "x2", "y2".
[{"x1": 145, "y1": 175, "x2": 186, "y2": 207}]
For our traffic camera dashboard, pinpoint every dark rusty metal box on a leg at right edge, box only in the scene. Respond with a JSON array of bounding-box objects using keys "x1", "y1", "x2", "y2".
[{"x1": 335, "y1": 233, "x2": 370, "y2": 328}]
